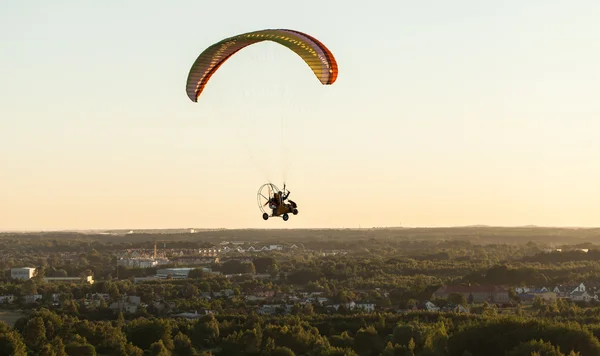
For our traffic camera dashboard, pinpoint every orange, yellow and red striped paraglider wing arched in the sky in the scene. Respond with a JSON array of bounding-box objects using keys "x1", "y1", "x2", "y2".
[{"x1": 186, "y1": 29, "x2": 338, "y2": 102}]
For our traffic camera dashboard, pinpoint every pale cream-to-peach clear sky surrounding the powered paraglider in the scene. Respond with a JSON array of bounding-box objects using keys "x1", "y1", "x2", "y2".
[{"x1": 0, "y1": 0, "x2": 600, "y2": 230}]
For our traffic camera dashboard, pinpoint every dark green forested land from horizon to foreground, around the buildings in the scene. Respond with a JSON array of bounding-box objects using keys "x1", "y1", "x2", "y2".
[{"x1": 0, "y1": 227, "x2": 600, "y2": 356}]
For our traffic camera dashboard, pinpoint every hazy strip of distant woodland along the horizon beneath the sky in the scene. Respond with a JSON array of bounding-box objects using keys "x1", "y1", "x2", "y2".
[{"x1": 0, "y1": 226, "x2": 600, "y2": 247}]
